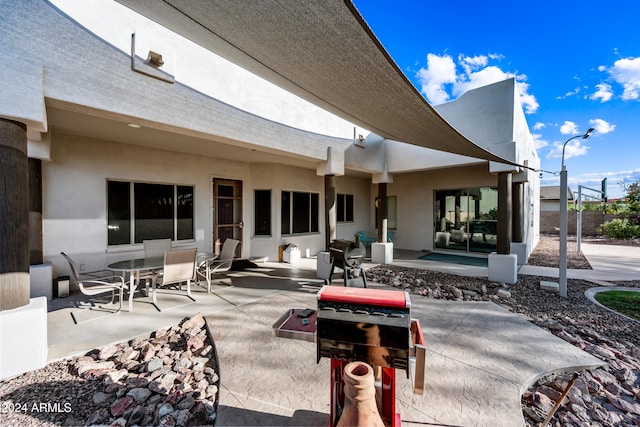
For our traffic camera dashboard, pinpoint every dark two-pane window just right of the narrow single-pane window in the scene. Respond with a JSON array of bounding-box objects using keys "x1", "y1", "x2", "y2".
[{"x1": 281, "y1": 191, "x2": 320, "y2": 234}]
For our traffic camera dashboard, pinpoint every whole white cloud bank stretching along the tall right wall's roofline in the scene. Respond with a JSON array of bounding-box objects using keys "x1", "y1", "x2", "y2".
[{"x1": 416, "y1": 53, "x2": 539, "y2": 113}]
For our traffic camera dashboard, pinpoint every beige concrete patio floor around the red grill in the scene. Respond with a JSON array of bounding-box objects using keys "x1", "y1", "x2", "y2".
[{"x1": 42, "y1": 252, "x2": 604, "y2": 426}]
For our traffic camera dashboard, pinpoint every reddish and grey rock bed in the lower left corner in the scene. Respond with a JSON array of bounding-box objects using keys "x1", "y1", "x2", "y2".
[{"x1": 0, "y1": 315, "x2": 219, "y2": 426}]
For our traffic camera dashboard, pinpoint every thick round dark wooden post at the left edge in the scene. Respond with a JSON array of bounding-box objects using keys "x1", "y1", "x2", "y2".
[{"x1": 0, "y1": 118, "x2": 30, "y2": 311}]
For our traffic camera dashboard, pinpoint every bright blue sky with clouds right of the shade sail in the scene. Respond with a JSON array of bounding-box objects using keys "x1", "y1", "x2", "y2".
[{"x1": 354, "y1": 0, "x2": 640, "y2": 198}]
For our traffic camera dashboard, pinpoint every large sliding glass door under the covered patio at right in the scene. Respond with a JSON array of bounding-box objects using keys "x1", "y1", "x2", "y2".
[{"x1": 434, "y1": 187, "x2": 498, "y2": 253}]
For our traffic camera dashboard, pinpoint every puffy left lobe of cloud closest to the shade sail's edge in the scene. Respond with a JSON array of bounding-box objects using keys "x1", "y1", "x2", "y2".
[{"x1": 417, "y1": 53, "x2": 456, "y2": 105}]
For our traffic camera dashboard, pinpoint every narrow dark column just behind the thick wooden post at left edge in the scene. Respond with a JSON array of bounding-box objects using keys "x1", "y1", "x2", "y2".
[{"x1": 29, "y1": 159, "x2": 43, "y2": 265}]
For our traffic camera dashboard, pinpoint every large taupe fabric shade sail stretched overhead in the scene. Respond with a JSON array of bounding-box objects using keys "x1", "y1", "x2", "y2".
[{"x1": 117, "y1": 0, "x2": 513, "y2": 164}]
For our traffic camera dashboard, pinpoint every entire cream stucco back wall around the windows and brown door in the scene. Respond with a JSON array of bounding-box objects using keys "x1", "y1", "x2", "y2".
[{"x1": 43, "y1": 133, "x2": 371, "y2": 277}]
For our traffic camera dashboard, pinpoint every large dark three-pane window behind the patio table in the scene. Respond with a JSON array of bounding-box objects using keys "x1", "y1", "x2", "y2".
[{"x1": 107, "y1": 181, "x2": 194, "y2": 245}]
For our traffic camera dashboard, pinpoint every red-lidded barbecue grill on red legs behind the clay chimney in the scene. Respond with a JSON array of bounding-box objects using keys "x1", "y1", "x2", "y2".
[{"x1": 316, "y1": 286, "x2": 425, "y2": 426}]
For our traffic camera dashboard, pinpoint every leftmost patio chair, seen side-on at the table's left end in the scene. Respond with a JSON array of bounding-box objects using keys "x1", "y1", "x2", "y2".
[{"x1": 60, "y1": 252, "x2": 127, "y2": 324}]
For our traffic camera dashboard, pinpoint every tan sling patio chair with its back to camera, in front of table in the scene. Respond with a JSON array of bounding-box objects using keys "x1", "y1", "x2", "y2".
[{"x1": 151, "y1": 248, "x2": 197, "y2": 311}]
